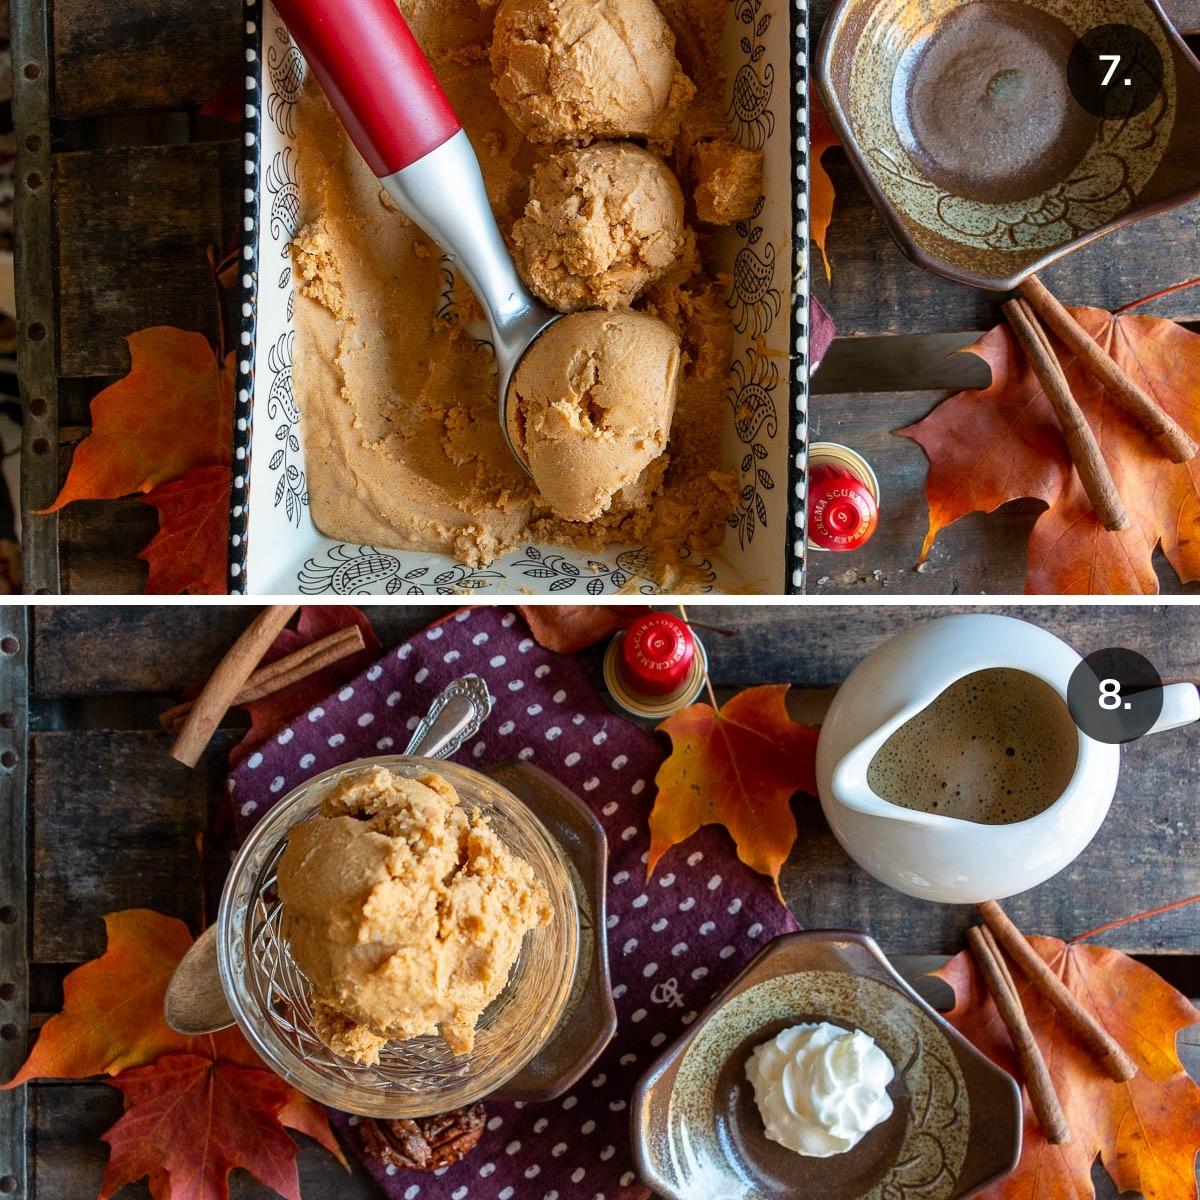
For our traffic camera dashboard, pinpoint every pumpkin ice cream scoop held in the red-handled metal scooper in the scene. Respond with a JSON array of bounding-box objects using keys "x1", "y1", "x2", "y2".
[{"x1": 508, "y1": 308, "x2": 679, "y2": 521}]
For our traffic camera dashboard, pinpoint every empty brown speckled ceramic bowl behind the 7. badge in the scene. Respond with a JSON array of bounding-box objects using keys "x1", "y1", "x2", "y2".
[{"x1": 817, "y1": 0, "x2": 1200, "y2": 290}]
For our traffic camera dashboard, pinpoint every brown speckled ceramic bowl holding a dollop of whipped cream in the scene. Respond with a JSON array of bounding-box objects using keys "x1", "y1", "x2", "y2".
[{"x1": 632, "y1": 930, "x2": 1021, "y2": 1200}]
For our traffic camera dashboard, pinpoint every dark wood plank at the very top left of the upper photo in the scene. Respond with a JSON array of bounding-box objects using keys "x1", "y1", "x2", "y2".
[{"x1": 54, "y1": 0, "x2": 245, "y2": 118}]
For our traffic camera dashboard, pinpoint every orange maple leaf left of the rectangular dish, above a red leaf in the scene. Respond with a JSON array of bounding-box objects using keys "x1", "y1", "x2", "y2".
[{"x1": 46, "y1": 325, "x2": 234, "y2": 512}]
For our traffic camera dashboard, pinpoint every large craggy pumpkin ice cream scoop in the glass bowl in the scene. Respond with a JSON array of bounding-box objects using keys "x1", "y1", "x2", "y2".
[{"x1": 278, "y1": 767, "x2": 552, "y2": 1064}]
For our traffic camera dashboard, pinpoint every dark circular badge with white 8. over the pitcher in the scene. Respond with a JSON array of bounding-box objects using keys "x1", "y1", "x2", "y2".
[{"x1": 1067, "y1": 646, "x2": 1163, "y2": 745}]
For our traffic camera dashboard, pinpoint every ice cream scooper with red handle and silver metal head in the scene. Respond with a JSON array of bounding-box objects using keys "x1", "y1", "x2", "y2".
[{"x1": 276, "y1": 0, "x2": 673, "y2": 516}]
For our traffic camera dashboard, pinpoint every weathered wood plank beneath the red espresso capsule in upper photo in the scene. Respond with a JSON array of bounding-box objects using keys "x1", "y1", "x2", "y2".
[{"x1": 808, "y1": 392, "x2": 1200, "y2": 600}]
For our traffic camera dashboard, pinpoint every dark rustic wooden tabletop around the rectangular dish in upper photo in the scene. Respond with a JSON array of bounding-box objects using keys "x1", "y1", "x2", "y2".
[{"x1": 12, "y1": 0, "x2": 1200, "y2": 595}]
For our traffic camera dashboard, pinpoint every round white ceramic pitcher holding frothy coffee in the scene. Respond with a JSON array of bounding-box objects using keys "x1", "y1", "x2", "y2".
[{"x1": 817, "y1": 613, "x2": 1200, "y2": 904}]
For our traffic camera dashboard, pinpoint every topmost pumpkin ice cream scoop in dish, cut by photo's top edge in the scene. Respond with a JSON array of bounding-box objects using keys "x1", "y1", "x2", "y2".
[{"x1": 492, "y1": 0, "x2": 696, "y2": 142}]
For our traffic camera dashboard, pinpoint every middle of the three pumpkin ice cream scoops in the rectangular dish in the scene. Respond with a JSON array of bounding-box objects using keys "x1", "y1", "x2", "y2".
[{"x1": 512, "y1": 142, "x2": 686, "y2": 312}]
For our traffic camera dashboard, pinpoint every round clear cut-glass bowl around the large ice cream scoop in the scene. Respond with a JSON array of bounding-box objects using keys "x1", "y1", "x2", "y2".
[{"x1": 217, "y1": 755, "x2": 580, "y2": 1118}]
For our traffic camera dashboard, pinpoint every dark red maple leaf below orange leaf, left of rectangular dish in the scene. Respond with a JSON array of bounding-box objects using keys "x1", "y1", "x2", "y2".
[{"x1": 138, "y1": 467, "x2": 233, "y2": 595}]
